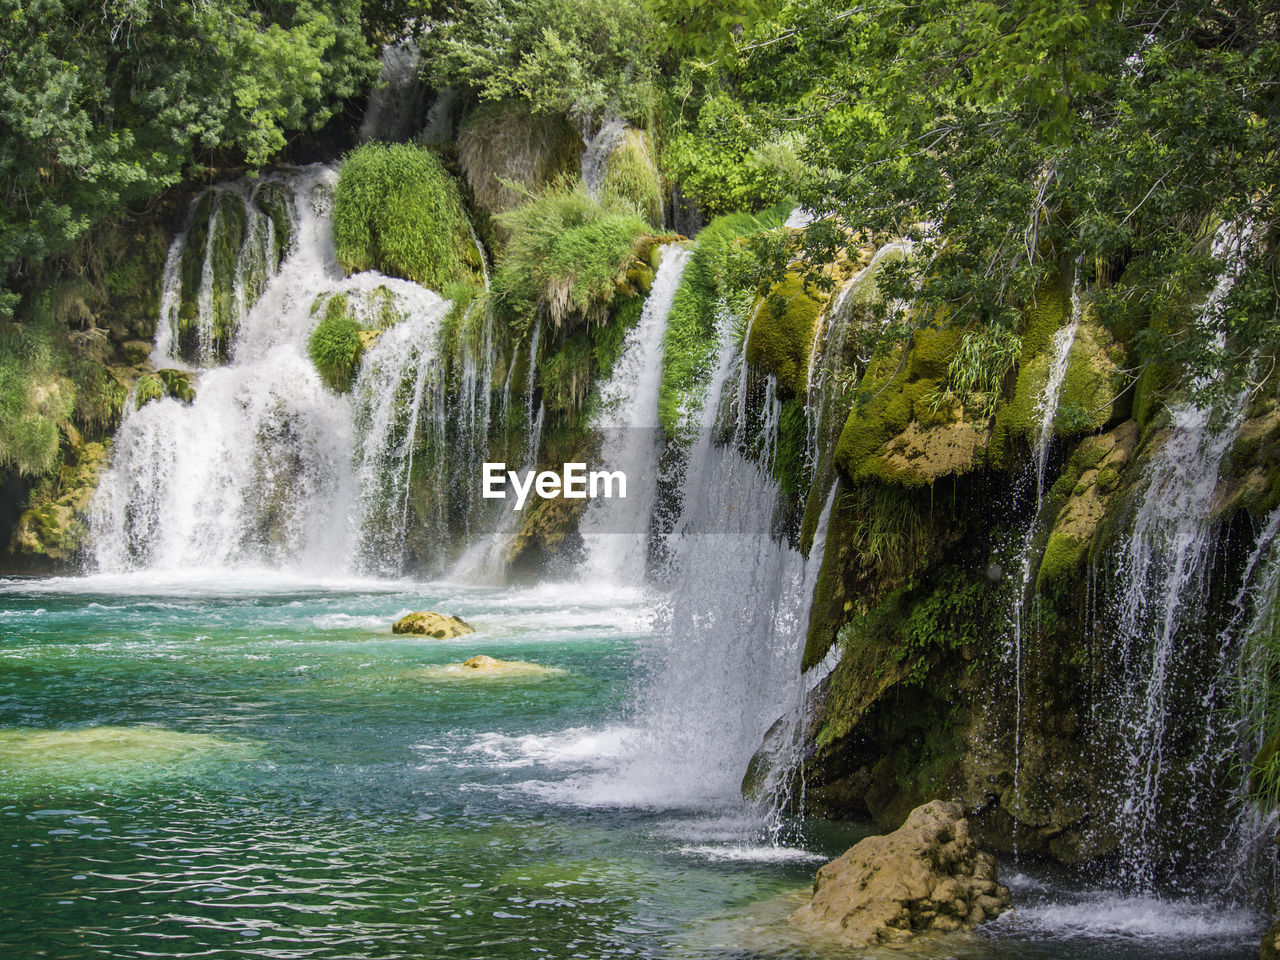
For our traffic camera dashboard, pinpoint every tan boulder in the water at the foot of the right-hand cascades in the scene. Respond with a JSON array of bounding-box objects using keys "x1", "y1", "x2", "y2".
[{"x1": 791, "y1": 800, "x2": 1009, "y2": 947}]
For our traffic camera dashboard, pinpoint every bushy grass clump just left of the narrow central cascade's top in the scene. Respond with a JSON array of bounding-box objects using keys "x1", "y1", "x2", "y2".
[{"x1": 493, "y1": 183, "x2": 649, "y2": 328}]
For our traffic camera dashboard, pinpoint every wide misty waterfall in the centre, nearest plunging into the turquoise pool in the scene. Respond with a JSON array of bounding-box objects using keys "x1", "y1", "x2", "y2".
[{"x1": 570, "y1": 311, "x2": 818, "y2": 808}]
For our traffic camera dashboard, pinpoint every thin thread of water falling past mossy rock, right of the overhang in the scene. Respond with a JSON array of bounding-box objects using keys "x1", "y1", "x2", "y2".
[{"x1": 1010, "y1": 276, "x2": 1083, "y2": 814}]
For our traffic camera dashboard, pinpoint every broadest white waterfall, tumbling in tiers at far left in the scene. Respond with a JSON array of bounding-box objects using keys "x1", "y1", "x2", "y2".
[{"x1": 91, "y1": 166, "x2": 463, "y2": 572}]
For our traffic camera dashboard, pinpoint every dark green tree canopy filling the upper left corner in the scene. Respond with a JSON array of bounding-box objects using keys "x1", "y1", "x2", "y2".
[{"x1": 0, "y1": 0, "x2": 376, "y2": 296}]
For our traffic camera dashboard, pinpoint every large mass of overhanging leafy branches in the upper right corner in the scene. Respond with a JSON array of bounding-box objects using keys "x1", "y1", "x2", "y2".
[{"x1": 663, "y1": 0, "x2": 1280, "y2": 399}]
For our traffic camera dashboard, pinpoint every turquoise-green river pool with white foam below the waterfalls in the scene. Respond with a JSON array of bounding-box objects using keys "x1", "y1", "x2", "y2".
[{"x1": 0, "y1": 570, "x2": 1265, "y2": 960}]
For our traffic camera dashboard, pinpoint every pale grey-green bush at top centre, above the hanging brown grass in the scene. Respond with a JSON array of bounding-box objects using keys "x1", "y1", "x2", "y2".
[{"x1": 422, "y1": 0, "x2": 655, "y2": 129}]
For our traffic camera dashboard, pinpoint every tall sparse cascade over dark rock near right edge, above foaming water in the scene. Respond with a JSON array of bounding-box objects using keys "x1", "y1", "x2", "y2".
[{"x1": 1100, "y1": 221, "x2": 1265, "y2": 890}]
